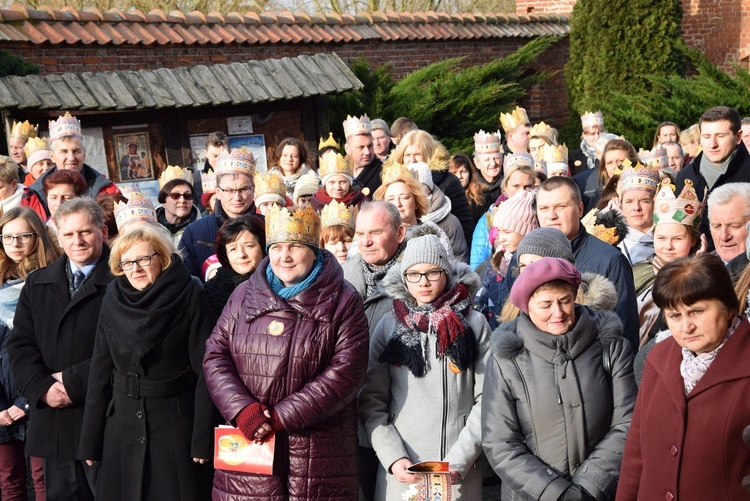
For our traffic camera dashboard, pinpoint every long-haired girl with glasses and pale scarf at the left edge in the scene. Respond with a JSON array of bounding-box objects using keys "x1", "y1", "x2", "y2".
[{"x1": 0, "y1": 207, "x2": 60, "y2": 499}]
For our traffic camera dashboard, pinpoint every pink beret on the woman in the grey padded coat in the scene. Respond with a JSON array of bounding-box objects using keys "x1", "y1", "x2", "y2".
[{"x1": 510, "y1": 257, "x2": 581, "y2": 314}]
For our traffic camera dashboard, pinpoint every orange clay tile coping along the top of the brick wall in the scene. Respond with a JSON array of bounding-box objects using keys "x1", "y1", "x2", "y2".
[{"x1": 0, "y1": 4, "x2": 570, "y2": 45}]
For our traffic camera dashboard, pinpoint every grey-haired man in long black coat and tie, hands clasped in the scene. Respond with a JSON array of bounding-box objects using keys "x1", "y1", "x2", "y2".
[{"x1": 8, "y1": 198, "x2": 112, "y2": 501}]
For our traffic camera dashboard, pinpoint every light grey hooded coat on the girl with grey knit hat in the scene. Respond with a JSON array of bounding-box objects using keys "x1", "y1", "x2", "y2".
[{"x1": 359, "y1": 263, "x2": 490, "y2": 500}]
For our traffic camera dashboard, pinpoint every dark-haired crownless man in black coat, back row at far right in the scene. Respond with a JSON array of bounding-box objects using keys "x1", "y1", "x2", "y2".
[{"x1": 676, "y1": 106, "x2": 750, "y2": 250}]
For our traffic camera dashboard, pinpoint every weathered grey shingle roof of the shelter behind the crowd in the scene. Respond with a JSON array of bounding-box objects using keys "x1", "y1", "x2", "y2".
[{"x1": 0, "y1": 54, "x2": 362, "y2": 111}]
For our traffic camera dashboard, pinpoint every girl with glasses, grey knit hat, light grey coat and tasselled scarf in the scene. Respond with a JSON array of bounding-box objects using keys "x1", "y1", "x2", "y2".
[{"x1": 359, "y1": 235, "x2": 490, "y2": 500}]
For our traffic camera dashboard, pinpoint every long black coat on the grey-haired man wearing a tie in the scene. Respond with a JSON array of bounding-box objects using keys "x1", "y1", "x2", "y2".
[{"x1": 8, "y1": 250, "x2": 112, "y2": 459}]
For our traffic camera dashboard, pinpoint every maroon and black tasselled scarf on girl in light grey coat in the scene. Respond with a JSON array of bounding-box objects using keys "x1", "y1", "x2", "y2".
[{"x1": 378, "y1": 284, "x2": 478, "y2": 377}]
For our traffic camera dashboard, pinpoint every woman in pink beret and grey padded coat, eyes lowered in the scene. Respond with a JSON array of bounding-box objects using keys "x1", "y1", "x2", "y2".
[{"x1": 482, "y1": 258, "x2": 636, "y2": 500}]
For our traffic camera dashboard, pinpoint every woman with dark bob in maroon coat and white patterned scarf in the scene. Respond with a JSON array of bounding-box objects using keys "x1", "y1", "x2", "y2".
[{"x1": 617, "y1": 254, "x2": 750, "y2": 501}]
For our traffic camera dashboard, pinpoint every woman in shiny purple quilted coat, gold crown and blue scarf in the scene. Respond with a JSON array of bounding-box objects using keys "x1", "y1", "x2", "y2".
[{"x1": 203, "y1": 206, "x2": 368, "y2": 501}]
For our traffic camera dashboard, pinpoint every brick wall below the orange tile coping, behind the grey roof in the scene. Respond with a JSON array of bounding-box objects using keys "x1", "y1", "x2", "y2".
[{"x1": 0, "y1": 38, "x2": 568, "y2": 128}]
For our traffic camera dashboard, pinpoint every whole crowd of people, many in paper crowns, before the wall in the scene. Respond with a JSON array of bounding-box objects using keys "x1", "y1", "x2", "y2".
[{"x1": 0, "y1": 102, "x2": 750, "y2": 501}]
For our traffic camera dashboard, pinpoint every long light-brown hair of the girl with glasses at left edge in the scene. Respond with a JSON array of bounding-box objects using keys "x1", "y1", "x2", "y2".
[{"x1": 0, "y1": 207, "x2": 61, "y2": 282}]
